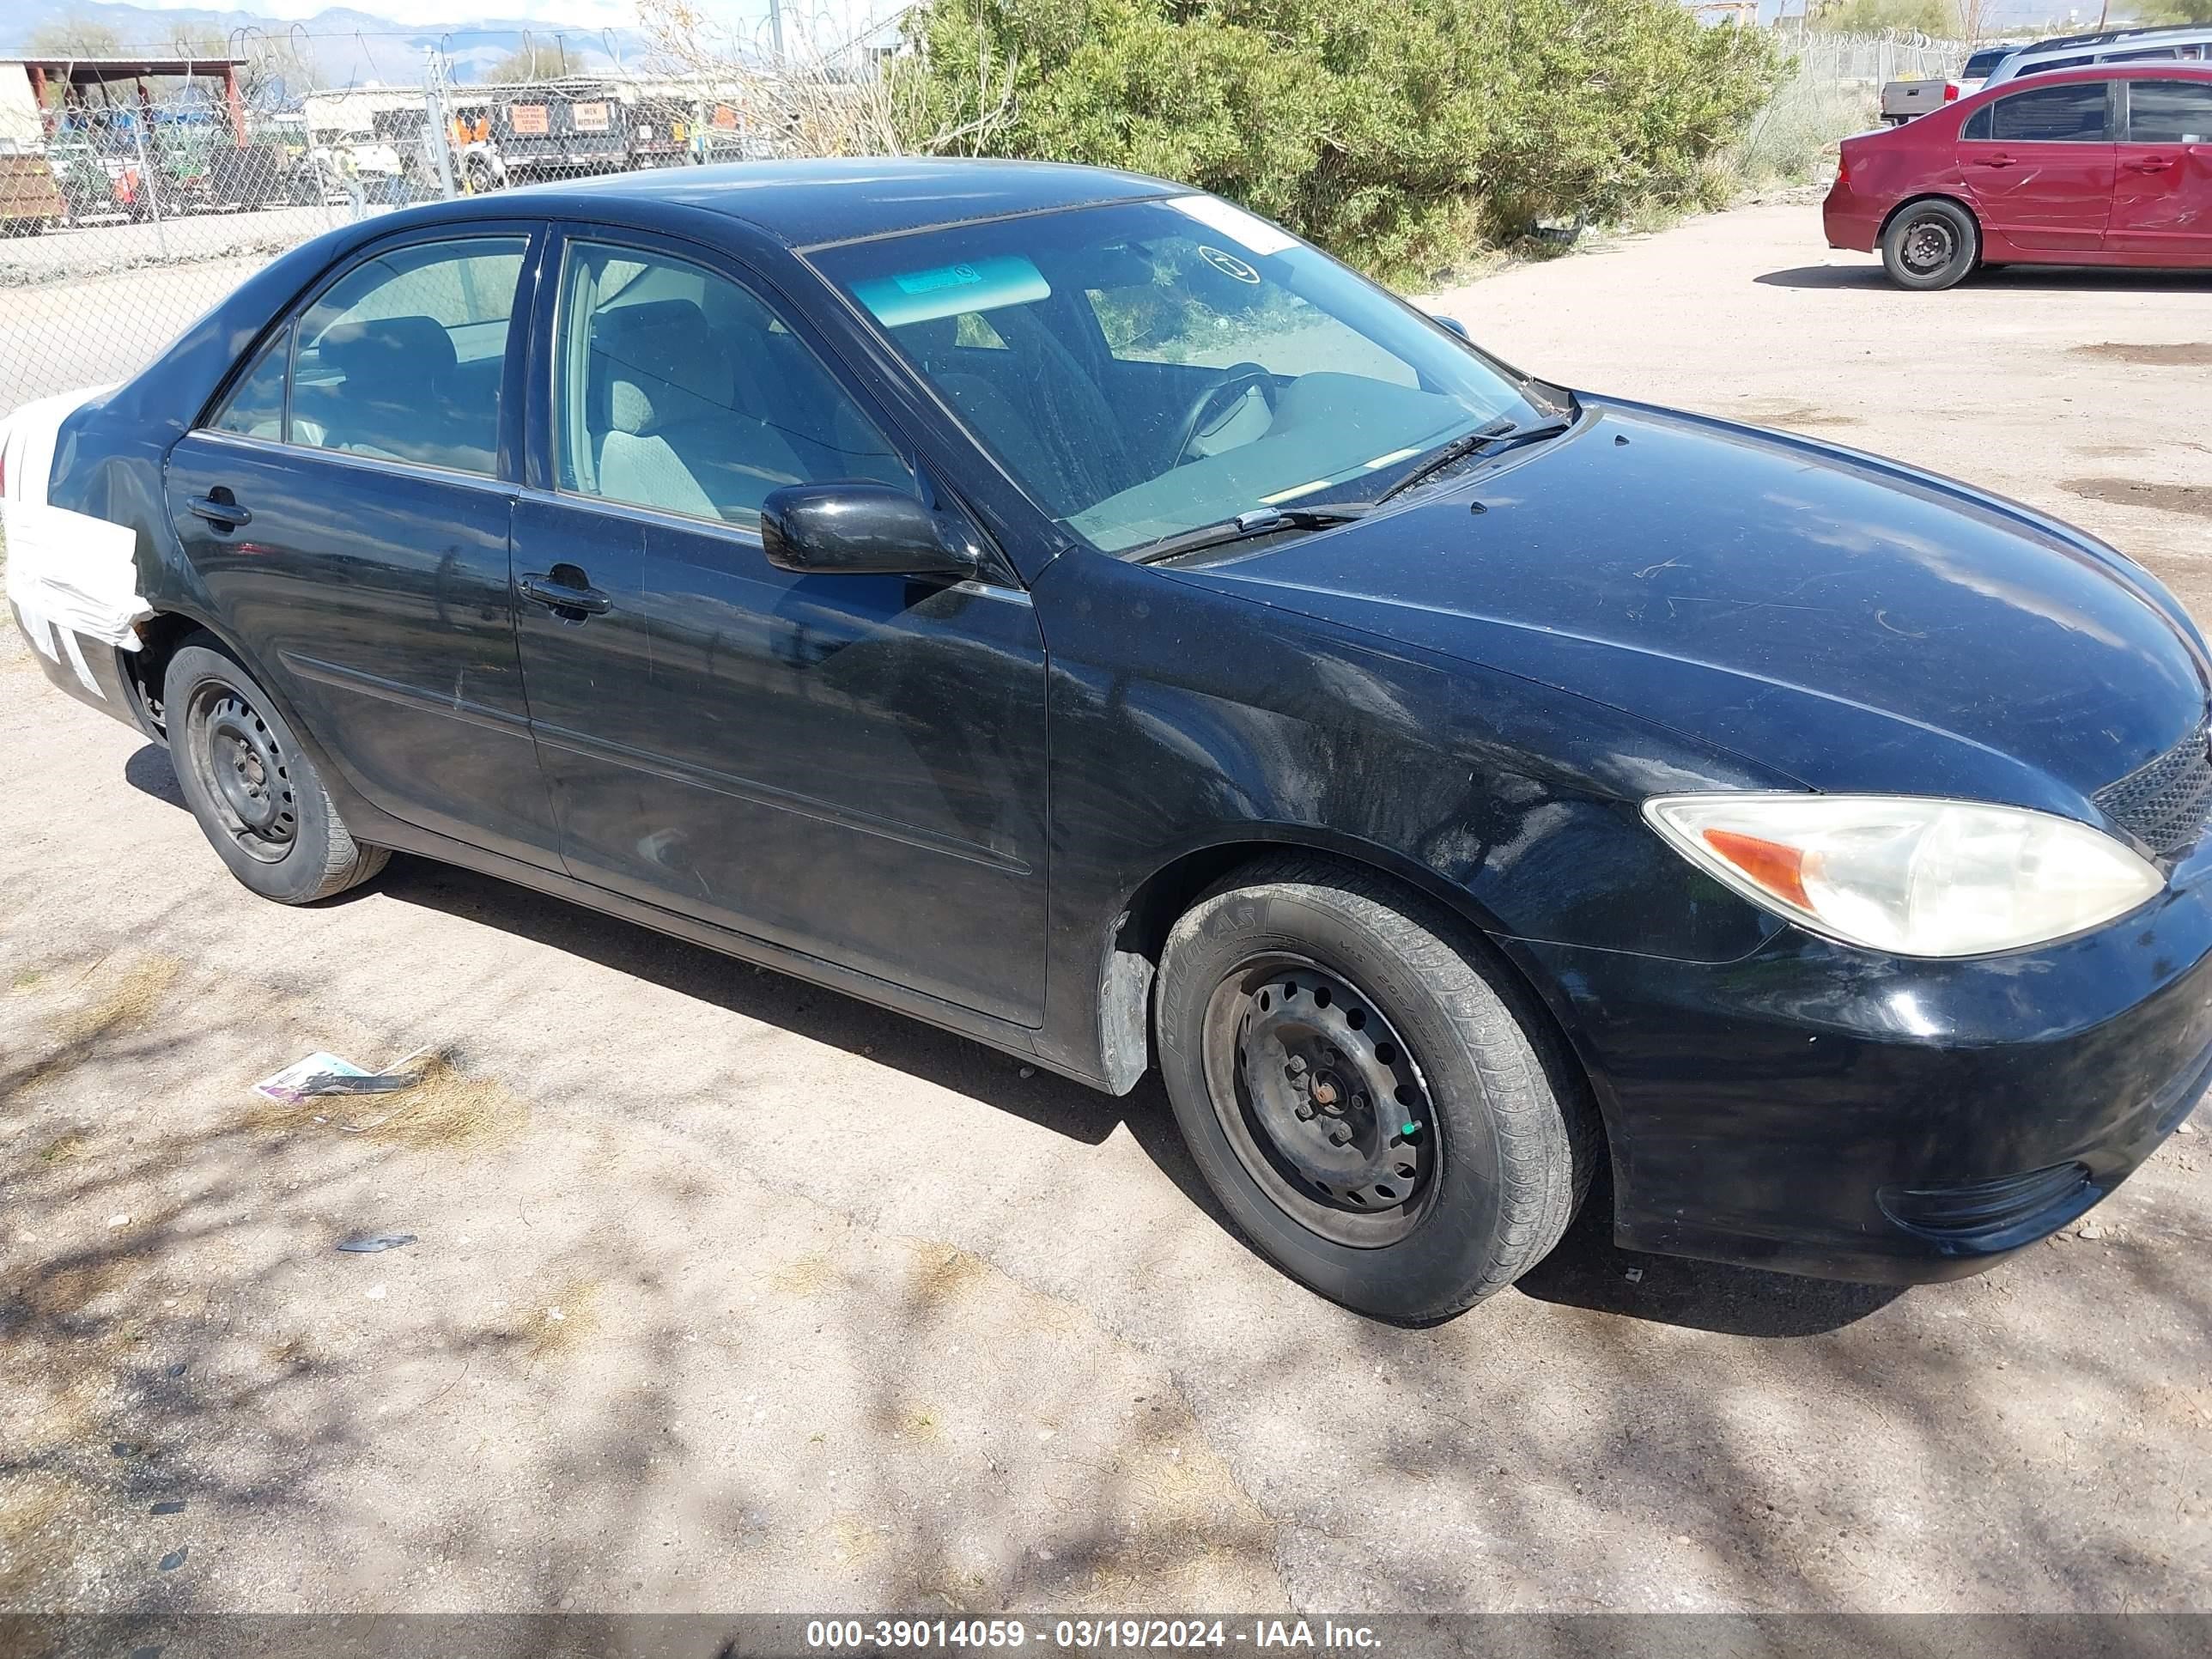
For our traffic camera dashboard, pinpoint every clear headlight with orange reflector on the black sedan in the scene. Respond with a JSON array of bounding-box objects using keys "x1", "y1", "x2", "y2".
[{"x1": 1644, "y1": 794, "x2": 2166, "y2": 956}]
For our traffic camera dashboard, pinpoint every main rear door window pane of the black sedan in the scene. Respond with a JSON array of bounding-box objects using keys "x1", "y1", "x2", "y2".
[{"x1": 288, "y1": 237, "x2": 529, "y2": 477}]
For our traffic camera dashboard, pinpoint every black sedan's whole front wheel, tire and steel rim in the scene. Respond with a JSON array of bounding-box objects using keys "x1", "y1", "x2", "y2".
[{"x1": 1157, "y1": 858, "x2": 1601, "y2": 1325}]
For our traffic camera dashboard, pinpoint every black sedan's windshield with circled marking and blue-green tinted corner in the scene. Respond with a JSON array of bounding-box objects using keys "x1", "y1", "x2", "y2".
[{"x1": 814, "y1": 197, "x2": 1559, "y2": 553}]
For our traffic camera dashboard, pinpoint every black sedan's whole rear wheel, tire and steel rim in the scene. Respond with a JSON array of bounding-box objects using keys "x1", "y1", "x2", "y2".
[{"x1": 161, "y1": 635, "x2": 392, "y2": 905}]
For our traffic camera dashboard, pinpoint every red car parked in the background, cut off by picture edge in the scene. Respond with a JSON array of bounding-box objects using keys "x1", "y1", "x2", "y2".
[{"x1": 1820, "y1": 62, "x2": 2212, "y2": 288}]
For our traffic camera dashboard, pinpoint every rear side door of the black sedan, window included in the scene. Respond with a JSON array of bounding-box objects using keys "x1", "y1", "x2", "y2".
[{"x1": 166, "y1": 223, "x2": 560, "y2": 869}]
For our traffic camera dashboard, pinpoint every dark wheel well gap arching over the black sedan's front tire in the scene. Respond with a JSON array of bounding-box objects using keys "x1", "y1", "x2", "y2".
[{"x1": 1099, "y1": 841, "x2": 1613, "y2": 1194}]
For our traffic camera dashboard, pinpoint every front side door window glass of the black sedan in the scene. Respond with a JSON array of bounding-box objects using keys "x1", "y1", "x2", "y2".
[{"x1": 557, "y1": 243, "x2": 911, "y2": 525}]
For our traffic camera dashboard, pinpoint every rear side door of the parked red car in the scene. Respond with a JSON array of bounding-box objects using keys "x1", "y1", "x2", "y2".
[{"x1": 1958, "y1": 80, "x2": 2119, "y2": 252}]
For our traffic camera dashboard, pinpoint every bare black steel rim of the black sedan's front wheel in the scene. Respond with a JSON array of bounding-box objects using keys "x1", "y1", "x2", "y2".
[{"x1": 1203, "y1": 953, "x2": 1444, "y2": 1249}]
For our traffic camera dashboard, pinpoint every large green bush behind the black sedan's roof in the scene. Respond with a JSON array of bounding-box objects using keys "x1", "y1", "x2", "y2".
[{"x1": 896, "y1": 0, "x2": 1783, "y2": 281}]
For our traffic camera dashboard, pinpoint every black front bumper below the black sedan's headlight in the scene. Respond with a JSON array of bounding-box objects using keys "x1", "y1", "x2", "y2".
[{"x1": 1517, "y1": 852, "x2": 2212, "y2": 1283}]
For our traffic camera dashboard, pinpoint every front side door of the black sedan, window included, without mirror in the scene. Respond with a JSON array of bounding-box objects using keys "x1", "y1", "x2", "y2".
[{"x1": 515, "y1": 230, "x2": 1046, "y2": 1024}]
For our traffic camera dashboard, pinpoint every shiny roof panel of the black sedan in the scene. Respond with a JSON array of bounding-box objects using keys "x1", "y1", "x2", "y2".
[{"x1": 484, "y1": 157, "x2": 1188, "y2": 248}]
